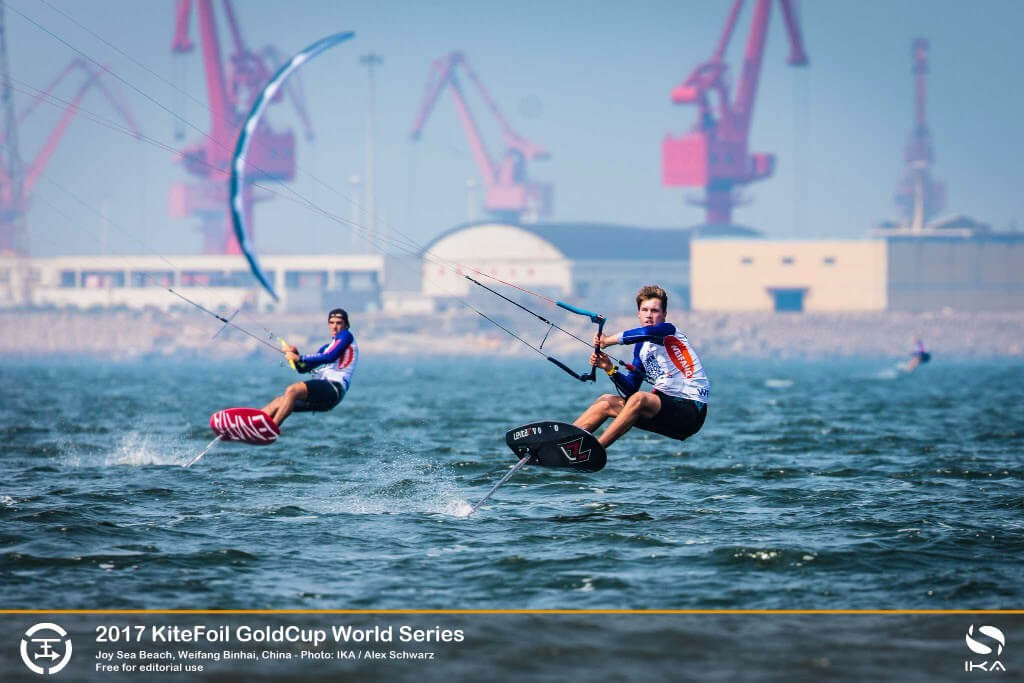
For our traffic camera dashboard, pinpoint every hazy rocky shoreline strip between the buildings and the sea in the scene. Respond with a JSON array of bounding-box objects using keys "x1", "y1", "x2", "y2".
[{"x1": 0, "y1": 310, "x2": 1024, "y2": 359}]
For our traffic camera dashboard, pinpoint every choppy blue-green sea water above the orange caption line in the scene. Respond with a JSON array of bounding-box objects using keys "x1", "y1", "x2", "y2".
[{"x1": 0, "y1": 355, "x2": 1024, "y2": 609}]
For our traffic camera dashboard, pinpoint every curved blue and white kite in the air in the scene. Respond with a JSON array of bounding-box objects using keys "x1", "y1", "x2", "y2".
[{"x1": 228, "y1": 31, "x2": 355, "y2": 301}]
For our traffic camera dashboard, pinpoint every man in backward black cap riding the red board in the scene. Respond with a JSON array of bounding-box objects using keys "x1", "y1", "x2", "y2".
[{"x1": 263, "y1": 308, "x2": 359, "y2": 425}]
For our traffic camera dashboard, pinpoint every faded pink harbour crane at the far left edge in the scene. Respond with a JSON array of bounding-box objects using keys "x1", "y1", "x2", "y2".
[{"x1": 0, "y1": 56, "x2": 141, "y2": 256}]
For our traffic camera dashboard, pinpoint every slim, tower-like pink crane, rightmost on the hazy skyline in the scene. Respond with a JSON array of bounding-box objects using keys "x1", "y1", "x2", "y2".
[{"x1": 895, "y1": 38, "x2": 946, "y2": 230}]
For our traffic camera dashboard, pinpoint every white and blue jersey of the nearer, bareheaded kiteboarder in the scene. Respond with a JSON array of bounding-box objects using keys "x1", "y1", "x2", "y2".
[{"x1": 611, "y1": 323, "x2": 711, "y2": 403}]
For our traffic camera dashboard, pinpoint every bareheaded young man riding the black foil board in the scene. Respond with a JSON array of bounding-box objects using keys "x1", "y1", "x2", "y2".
[{"x1": 572, "y1": 285, "x2": 711, "y2": 447}]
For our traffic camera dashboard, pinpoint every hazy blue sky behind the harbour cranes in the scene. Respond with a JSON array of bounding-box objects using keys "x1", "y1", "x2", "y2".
[{"x1": 6, "y1": 0, "x2": 1024, "y2": 256}]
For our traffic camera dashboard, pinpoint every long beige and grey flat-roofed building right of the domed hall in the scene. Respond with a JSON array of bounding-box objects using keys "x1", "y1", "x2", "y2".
[{"x1": 690, "y1": 229, "x2": 1024, "y2": 312}]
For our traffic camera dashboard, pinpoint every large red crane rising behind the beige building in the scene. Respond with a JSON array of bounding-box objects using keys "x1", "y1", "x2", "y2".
[{"x1": 662, "y1": 0, "x2": 807, "y2": 224}]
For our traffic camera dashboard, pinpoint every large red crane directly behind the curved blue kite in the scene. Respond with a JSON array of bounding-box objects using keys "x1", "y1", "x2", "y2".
[{"x1": 170, "y1": 0, "x2": 301, "y2": 254}]
